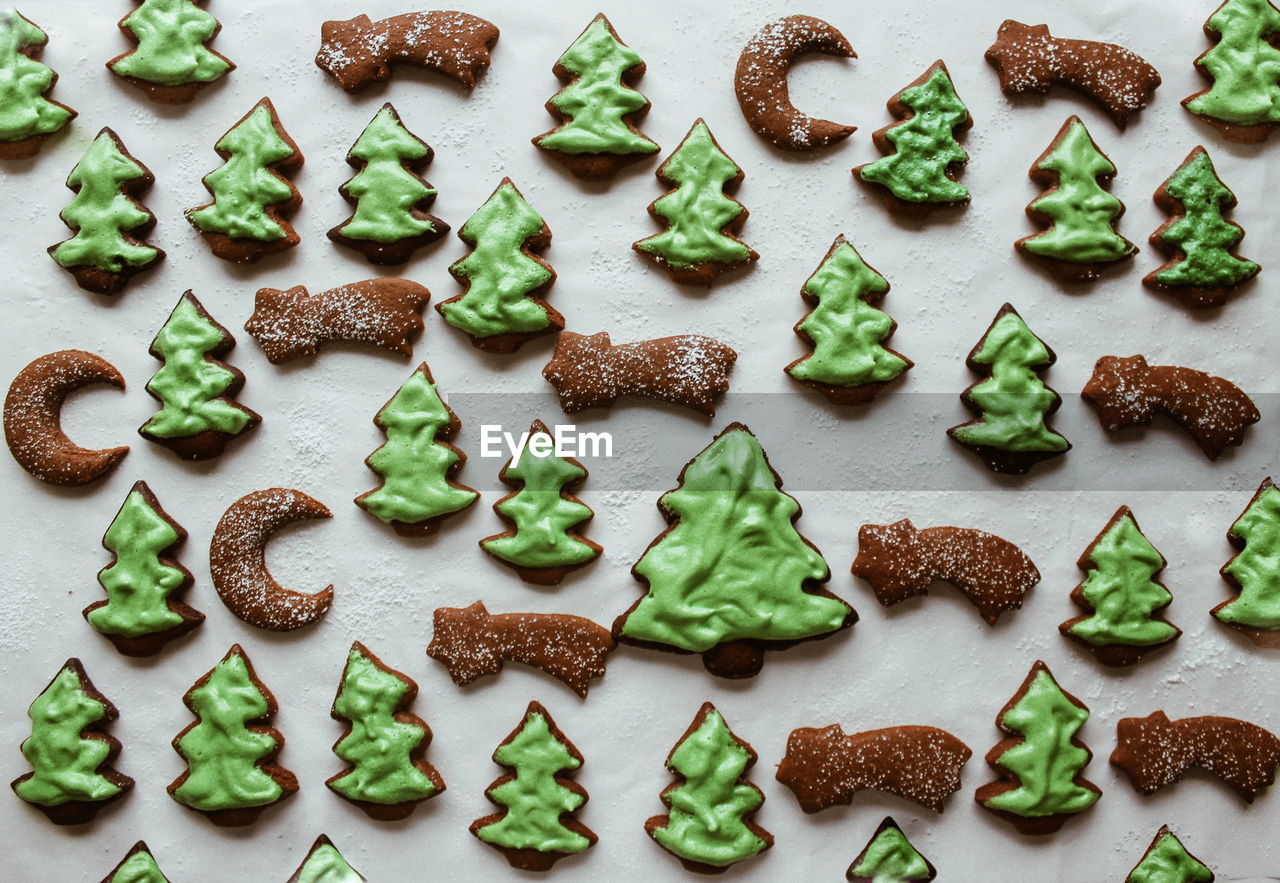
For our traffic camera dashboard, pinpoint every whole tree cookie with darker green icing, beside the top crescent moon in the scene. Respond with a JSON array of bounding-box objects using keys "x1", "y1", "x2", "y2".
[{"x1": 854, "y1": 60, "x2": 973, "y2": 216}]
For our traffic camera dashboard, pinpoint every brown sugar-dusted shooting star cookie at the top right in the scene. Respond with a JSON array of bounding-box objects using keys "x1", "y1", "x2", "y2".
[{"x1": 987, "y1": 19, "x2": 1160, "y2": 129}]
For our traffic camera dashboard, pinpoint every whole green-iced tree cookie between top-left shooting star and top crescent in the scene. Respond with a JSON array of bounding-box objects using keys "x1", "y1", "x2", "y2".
[{"x1": 534, "y1": 13, "x2": 658, "y2": 178}]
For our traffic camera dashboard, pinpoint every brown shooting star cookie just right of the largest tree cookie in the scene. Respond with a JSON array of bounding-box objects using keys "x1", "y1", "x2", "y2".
[{"x1": 852, "y1": 518, "x2": 1039, "y2": 626}]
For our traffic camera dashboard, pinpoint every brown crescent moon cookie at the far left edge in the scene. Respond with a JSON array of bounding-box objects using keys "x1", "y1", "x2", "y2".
[{"x1": 4, "y1": 349, "x2": 129, "y2": 486}]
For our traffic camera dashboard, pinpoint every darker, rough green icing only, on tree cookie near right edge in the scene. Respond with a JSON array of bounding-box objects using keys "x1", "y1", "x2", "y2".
[{"x1": 1155, "y1": 147, "x2": 1261, "y2": 288}]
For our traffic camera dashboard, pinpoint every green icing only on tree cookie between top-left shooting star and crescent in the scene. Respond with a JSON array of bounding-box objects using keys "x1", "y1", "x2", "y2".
[{"x1": 534, "y1": 15, "x2": 658, "y2": 155}]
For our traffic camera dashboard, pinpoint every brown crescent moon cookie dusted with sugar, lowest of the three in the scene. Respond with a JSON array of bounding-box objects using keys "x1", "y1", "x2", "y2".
[{"x1": 209, "y1": 488, "x2": 333, "y2": 632}]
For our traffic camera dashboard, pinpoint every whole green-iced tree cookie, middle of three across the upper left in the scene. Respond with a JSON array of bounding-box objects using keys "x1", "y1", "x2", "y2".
[{"x1": 187, "y1": 99, "x2": 302, "y2": 264}]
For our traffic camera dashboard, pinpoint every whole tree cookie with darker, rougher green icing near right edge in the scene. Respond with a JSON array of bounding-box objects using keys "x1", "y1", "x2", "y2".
[{"x1": 1142, "y1": 147, "x2": 1261, "y2": 307}]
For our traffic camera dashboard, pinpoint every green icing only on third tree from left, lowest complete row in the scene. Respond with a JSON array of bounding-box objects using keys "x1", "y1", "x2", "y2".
[{"x1": 329, "y1": 648, "x2": 436, "y2": 804}]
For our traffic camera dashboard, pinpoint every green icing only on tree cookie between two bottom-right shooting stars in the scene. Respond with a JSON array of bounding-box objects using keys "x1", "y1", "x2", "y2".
[{"x1": 983, "y1": 668, "x2": 1100, "y2": 818}]
